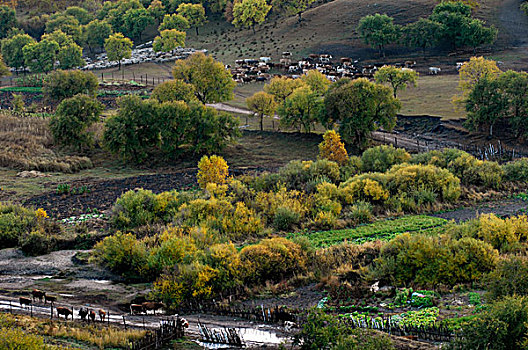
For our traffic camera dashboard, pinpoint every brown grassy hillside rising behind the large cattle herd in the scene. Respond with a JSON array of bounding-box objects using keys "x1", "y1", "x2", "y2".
[{"x1": 187, "y1": 0, "x2": 507, "y2": 63}]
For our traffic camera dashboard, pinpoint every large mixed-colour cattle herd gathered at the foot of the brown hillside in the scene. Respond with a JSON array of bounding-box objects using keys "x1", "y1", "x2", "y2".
[{"x1": 226, "y1": 52, "x2": 452, "y2": 84}]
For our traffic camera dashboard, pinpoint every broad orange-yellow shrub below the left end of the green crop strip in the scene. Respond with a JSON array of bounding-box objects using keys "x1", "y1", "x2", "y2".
[{"x1": 240, "y1": 238, "x2": 307, "y2": 283}]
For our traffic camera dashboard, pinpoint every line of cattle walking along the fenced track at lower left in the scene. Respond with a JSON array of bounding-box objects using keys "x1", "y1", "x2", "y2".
[{"x1": 19, "y1": 289, "x2": 169, "y2": 322}]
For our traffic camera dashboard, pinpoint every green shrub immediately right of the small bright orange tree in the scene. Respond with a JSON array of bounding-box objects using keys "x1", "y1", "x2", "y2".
[{"x1": 361, "y1": 145, "x2": 411, "y2": 173}]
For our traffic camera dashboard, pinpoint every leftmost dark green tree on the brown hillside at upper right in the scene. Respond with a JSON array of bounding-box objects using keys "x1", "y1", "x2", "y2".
[{"x1": 357, "y1": 13, "x2": 400, "y2": 57}]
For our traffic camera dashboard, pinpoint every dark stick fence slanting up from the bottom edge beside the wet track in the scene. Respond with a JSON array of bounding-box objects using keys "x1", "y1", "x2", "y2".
[{"x1": 128, "y1": 316, "x2": 186, "y2": 350}]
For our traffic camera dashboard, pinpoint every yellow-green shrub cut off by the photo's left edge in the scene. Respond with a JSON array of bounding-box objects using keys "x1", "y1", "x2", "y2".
[{"x1": 0, "y1": 203, "x2": 37, "y2": 249}]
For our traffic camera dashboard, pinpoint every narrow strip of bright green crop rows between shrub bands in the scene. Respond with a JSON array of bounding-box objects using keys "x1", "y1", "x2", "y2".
[{"x1": 292, "y1": 215, "x2": 448, "y2": 247}]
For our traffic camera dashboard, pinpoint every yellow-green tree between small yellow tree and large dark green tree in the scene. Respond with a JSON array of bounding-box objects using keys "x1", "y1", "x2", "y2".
[{"x1": 278, "y1": 86, "x2": 324, "y2": 132}]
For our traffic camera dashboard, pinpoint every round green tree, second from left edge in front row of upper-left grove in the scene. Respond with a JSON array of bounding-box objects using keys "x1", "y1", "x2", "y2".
[{"x1": 22, "y1": 39, "x2": 59, "y2": 73}]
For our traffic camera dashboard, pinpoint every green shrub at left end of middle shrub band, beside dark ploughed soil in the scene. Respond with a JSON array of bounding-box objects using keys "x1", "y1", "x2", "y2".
[{"x1": 110, "y1": 189, "x2": 157, "y2": 231}]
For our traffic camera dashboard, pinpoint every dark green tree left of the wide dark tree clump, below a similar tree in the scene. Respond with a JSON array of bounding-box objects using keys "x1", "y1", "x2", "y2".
[{"x1": 49, "y1": 95, "x2": 103, "y2": 151}]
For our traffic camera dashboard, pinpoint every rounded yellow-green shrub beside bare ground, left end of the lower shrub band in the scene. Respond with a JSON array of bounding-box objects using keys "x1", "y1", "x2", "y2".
[{"x1": 90, "y1": 232, "x2": 148, "y2": 280}]
